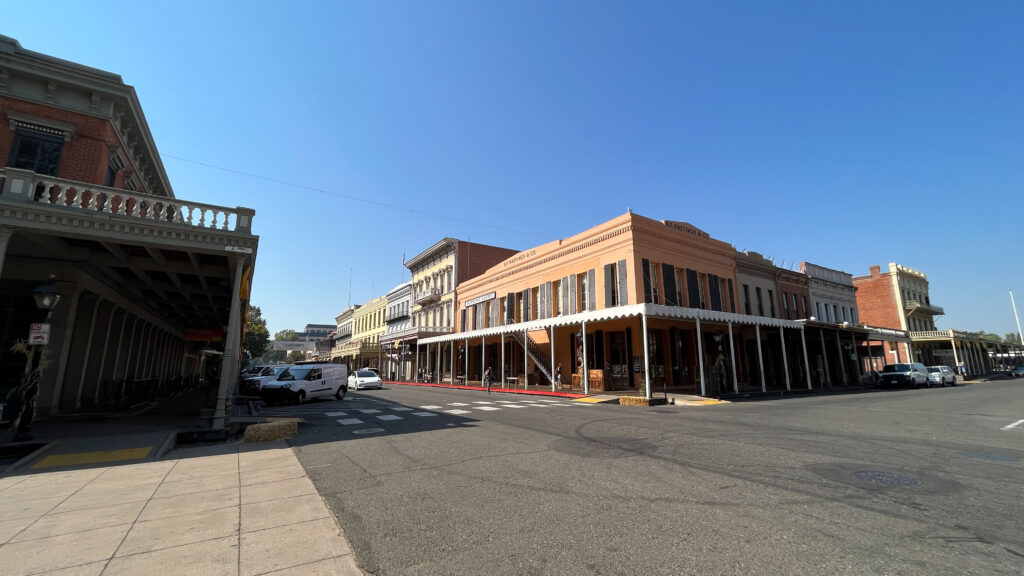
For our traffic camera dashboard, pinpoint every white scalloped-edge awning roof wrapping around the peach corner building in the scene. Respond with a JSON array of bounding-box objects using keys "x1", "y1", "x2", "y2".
[{"x1": 419, "y1": 304, "x2": 804, "y2": 344}]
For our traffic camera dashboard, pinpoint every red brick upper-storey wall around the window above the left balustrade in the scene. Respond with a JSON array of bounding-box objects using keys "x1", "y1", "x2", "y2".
[{"x1": 0, "y1": 97, "x2": 131, "y2": 184}]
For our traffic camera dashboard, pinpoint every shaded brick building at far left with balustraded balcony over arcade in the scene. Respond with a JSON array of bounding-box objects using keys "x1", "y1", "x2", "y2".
[{"x1": 0, "y1": 36, "x2": 258, "y2": 426}]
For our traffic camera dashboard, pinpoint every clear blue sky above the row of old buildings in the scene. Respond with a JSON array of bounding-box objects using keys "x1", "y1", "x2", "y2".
[{"x1": 0, "y1": 0, "x2": 1024, "y2": 334}]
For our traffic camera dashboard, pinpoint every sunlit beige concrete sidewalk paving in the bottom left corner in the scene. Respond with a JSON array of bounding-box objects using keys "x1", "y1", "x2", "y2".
[{"x1": 0, "y1": 442, "x2": 362, "y2": 576}]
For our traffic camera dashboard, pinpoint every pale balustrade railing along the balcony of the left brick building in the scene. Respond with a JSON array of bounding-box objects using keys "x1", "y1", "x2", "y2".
[{"x1": 0, "y1": 168, "x2": 256, "y2": 234}]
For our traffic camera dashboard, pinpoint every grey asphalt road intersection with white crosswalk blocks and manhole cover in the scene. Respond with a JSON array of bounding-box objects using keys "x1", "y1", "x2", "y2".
[{"x1": 278, "y1": 380, "x2": 1024, "y2": 576}]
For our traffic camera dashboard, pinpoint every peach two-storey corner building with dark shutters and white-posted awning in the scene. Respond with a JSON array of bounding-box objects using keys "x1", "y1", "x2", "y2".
[{"x1": 420, "y1": 212, "x2": 810, "y2": 397}]
